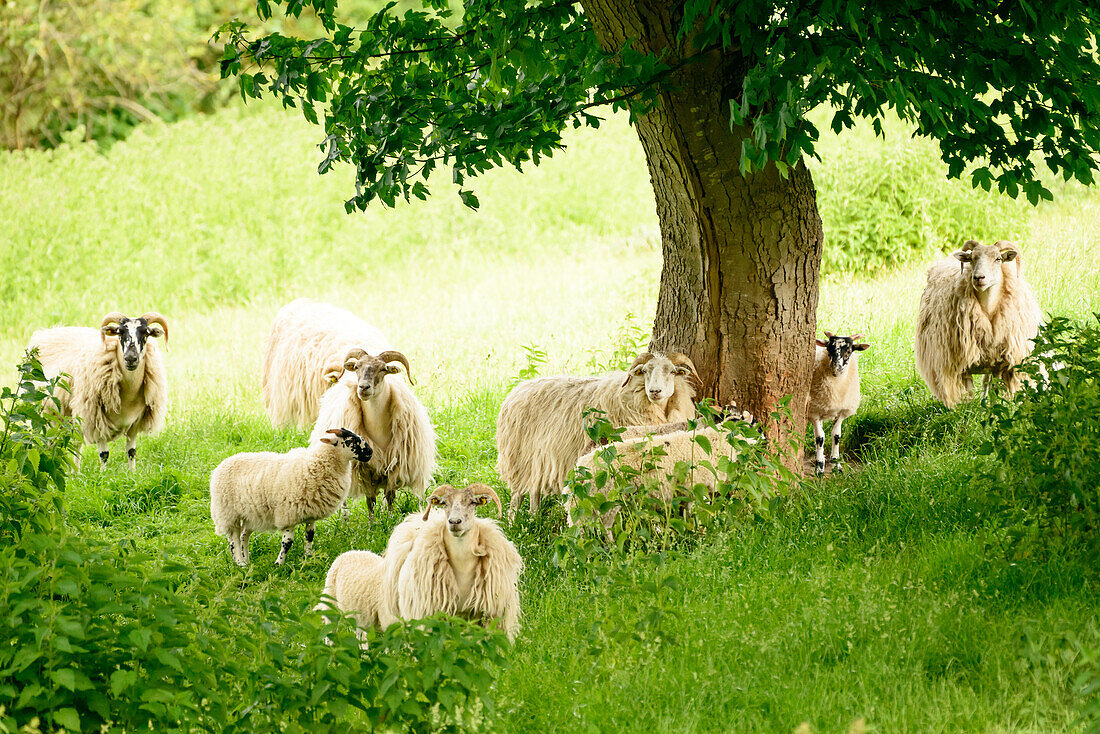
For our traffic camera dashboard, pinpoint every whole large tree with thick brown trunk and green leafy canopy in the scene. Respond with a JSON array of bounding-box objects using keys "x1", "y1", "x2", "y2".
[{"x1": 222, "y1": 0, "x2": 1100, "y2": 453}]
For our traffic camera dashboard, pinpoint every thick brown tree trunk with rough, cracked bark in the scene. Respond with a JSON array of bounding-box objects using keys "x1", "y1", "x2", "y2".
[{"x1": 581, "y1": 0, "x2": 823, "y2": 453}]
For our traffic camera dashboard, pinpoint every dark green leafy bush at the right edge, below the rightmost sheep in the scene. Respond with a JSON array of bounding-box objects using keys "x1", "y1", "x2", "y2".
[{"x1": 979, "y1": 315, "x2": 1100, "y2": 557}]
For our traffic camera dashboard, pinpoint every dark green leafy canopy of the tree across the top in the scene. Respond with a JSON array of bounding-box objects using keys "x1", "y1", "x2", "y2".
[{"x1": 220, "y1": 0, "x2": 1100, "y2": 211}]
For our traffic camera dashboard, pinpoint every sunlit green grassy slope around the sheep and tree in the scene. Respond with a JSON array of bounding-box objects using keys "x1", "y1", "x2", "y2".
[{"x1": 0, "y1": 104, "x2": 1100, "y2": 732}]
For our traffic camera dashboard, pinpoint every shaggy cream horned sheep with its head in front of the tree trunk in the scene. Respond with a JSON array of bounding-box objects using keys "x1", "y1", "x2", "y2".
[{"x1": 496, "y1": 352, "x2": 699, "y2": 516}]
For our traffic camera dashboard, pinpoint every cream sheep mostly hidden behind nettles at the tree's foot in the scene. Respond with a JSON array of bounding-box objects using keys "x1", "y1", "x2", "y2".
[{"x1": 565, "y1": 422, "x2": 756, "y2": 540}]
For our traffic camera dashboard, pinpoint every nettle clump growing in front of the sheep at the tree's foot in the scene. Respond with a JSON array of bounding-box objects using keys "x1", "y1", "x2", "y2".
[{"x1": 559, "y1": 402, "x2": 799, "y2": 559}]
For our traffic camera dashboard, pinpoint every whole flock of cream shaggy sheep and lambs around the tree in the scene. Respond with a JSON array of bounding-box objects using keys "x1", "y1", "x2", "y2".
[{"x1": 23, "y1": 240, "x2": 1041, "y2": 638}]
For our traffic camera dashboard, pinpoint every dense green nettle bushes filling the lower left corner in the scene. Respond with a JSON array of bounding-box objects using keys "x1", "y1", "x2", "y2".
[{"x1": 0, "y1": 354, "x2": 506, "y2": 733}]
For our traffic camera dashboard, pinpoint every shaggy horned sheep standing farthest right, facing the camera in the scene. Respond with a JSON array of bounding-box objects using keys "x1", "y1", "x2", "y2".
[{"x1": 915, "y1": 240, "x2": 1042, "y2": 407}]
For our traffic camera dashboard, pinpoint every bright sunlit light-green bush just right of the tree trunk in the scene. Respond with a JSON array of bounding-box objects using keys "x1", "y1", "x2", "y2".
[{"x1": 813, "y1": 139, "x2": 1027, "y2": 273}]
